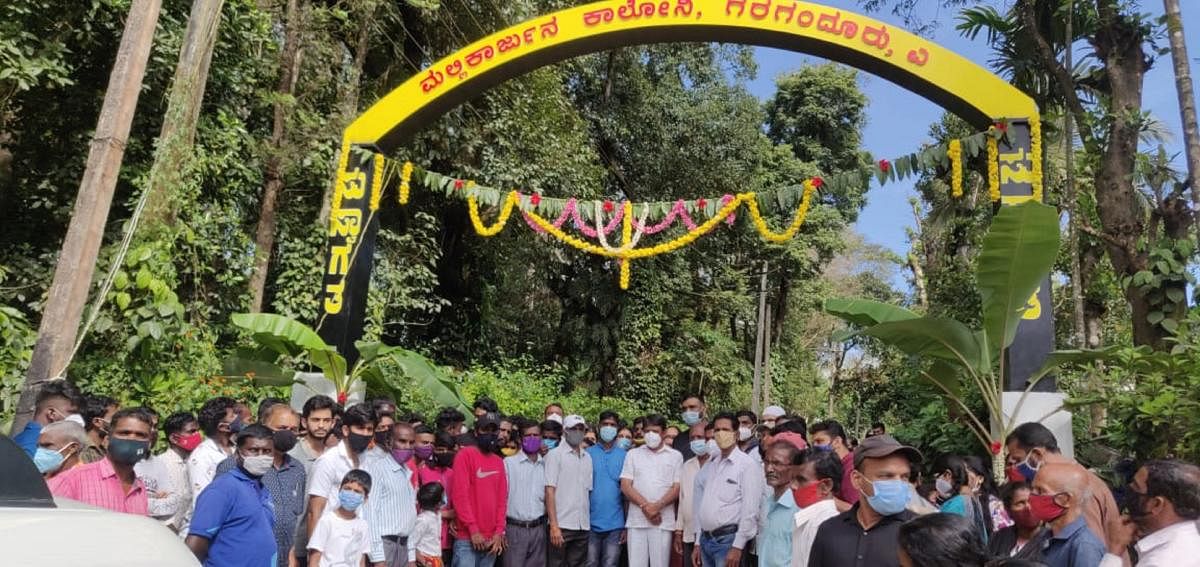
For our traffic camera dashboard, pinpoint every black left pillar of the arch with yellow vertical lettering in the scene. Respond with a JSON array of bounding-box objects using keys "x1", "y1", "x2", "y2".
[{"x1": 317, "y1": 148, "x2": 383, "y2": 366}]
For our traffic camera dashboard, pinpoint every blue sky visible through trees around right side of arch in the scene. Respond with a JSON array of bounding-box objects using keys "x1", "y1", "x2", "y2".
[{"x1": 748, "y1": 0, "x2": 1200, "y2": 270}]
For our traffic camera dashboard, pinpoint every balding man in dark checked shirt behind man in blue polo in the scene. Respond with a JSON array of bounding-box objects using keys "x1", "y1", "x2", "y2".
[{"x1": 217, "y1": 404, "x2": 308, "y2": 567}]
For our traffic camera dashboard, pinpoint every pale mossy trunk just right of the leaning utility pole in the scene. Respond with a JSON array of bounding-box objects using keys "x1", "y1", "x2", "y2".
[{"x1": 144, "y1": 0, "x2": 224, "y2": 227}]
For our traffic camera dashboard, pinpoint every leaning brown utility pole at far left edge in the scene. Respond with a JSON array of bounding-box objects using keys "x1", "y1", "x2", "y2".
[{"x1": 12, "y1": 0, "x2": 162, "y2": 431}]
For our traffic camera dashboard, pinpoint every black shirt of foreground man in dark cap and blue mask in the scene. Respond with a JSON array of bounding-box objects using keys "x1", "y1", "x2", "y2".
[{"x1": 808, "y1": 505, "x2": 917, "y2": 567}]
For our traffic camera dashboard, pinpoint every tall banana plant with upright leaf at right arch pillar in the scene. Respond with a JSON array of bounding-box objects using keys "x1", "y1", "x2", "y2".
[{"x1": 824, "y1": 201, "x2": 1111, "y2": 478}]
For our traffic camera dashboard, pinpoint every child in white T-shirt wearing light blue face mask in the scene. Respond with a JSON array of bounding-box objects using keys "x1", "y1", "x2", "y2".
[{"x1": 308, "y1": 468, "x2": 371, "y2": 567}]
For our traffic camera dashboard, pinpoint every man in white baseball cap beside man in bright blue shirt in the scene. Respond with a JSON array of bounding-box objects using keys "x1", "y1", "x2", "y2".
[{"x1": 546, "y1": 414, "x2": 592, "y2": 567}]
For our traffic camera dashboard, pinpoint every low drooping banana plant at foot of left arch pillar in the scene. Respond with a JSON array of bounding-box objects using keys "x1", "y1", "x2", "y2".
[{"x1": 223, "y1": 314, "x2": 469, "y2": 413}]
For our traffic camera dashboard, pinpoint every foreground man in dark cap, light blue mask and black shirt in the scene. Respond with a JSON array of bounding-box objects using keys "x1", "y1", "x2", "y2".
[{"x1": 809, "y1": 435, "x2": 922, "y2": 567}]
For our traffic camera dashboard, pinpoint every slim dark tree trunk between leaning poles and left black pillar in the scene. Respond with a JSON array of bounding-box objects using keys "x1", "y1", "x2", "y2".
[{"x1": 250, "y1": 0, "x2": 304, "y2": 314}]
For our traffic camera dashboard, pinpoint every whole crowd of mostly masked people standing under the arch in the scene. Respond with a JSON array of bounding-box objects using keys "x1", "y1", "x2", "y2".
[{"x1": 13, "y1": 381, "x2": 1200, "y2": 567}]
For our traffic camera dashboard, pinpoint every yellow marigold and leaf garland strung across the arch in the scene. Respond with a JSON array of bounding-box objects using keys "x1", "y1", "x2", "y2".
[{"x1": 372, "y1": 125, "x2": 1022, "y2": 290}]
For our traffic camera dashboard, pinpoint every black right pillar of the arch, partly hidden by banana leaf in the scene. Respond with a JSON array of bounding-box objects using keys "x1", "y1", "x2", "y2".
[{"x1": 1000, "y1": 121, "x2": 1057, "y2": 392}]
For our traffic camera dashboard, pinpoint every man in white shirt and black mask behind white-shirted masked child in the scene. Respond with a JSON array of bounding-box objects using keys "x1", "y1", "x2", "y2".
[{"x1": 305, "y1": 402, "x2": 378, "y2": 542}]
